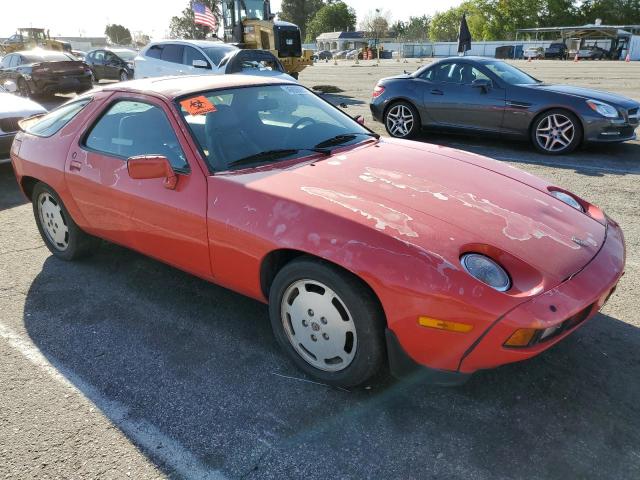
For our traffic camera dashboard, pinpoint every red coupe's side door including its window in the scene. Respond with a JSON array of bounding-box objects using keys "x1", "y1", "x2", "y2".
[{"x1": 66, "y1": 92, "x2": 211, "y2": 278}]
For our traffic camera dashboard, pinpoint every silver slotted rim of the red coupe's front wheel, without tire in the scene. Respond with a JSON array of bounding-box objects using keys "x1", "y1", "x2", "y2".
[{"x1": 280, "y1": 279, "x2": 357, "y2": 372}]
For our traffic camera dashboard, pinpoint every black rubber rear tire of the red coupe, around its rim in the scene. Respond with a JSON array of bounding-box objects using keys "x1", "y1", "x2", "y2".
[{"x1": 31, "y1": 182, "x2": 99, "y2": 261}]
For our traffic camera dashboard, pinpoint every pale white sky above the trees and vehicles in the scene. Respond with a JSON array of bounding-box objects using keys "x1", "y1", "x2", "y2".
[{"x1": 0, "y1": 0, "x2": 461, "y2": 38}]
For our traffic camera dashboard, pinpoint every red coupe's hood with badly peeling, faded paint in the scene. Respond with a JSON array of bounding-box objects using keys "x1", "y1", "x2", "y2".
[{"x1": 278, "y1": 139, "x2": 606, "y2": 282}]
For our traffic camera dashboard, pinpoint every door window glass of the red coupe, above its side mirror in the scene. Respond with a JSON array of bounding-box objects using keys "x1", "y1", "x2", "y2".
[{"x1": 84, "y1": 100, "x2": 189, "y2": 172}]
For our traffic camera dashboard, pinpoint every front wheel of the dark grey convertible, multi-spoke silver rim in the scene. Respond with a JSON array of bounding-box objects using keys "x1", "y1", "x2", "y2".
[{"x1": 531, "y1": 109, "x2": 582, "y2": 155}]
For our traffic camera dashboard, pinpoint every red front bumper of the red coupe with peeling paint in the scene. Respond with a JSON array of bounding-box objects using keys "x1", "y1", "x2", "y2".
[{"x1": 387, "y1": 219, "x2": 625, "y2": 385}]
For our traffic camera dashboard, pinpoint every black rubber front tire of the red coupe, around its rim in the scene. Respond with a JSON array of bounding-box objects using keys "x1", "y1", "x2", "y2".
[{"x1": 269, "y1": 257, "x2": 386, "y2": 388}]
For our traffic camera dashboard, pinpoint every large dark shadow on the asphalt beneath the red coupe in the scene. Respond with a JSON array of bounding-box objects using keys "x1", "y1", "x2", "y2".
[{"x1": 24, "y1": 249, "x2": 640, "y2": 479}]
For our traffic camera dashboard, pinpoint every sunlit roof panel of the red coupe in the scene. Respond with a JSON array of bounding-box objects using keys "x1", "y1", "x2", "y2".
[{"x1": 101, "y1": 74, "x2": 299, "y2": 99}]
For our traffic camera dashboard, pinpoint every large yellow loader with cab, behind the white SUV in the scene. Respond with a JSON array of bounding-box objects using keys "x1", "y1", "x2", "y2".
[{"x1": 222, "y1": 0, "x2": 313, "y2": 79}]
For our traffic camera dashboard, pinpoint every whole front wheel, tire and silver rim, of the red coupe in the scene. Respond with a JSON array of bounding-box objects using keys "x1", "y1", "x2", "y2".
[{"x1": 269, "y1": 258, "x2": 384, "y2": 387}]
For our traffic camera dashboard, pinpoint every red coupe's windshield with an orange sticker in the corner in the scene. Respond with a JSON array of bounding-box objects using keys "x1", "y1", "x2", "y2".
[{"x1": 177, "y1": 84, "x2": 376, "y2": 172}]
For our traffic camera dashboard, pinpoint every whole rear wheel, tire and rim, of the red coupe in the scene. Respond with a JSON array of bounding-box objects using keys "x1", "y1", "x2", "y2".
[{"x1": 32, "y1": 183, "x2": 98, "y2": 261}]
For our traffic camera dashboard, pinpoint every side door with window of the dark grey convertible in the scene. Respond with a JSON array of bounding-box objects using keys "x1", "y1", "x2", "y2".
[{"x1": 423, "y1": 61, "x2": 505, "y2": 131}]
